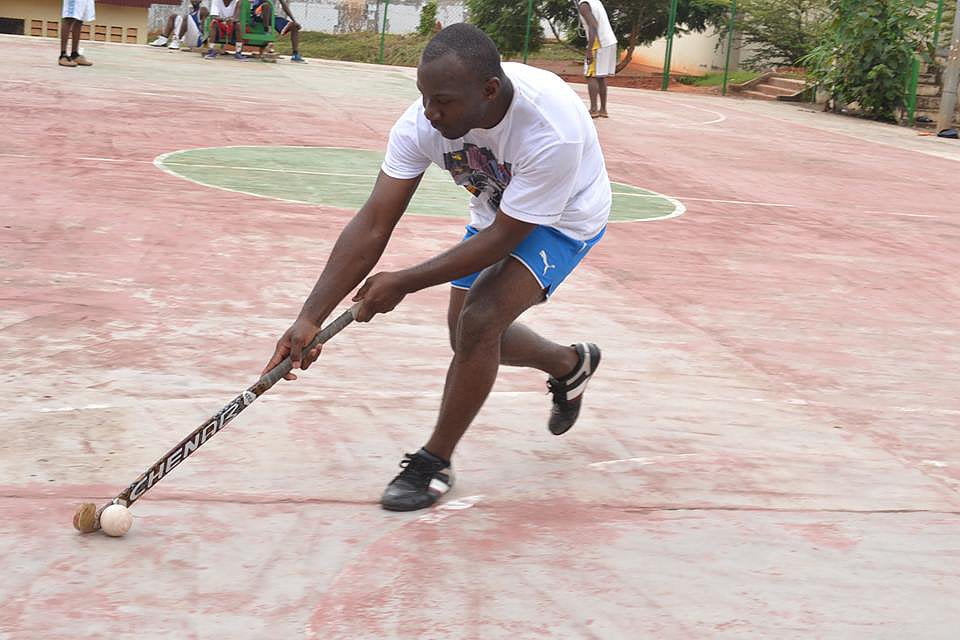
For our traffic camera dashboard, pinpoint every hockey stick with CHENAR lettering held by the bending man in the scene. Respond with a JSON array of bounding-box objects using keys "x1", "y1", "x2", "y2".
[{"x1": 73, "y1": 303, "x2": 360, "y2": 533}]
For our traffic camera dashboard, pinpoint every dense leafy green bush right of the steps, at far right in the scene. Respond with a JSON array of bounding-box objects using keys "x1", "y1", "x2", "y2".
[{"x1": 803, "y1": 0, "x2": 933, "y2": 122}]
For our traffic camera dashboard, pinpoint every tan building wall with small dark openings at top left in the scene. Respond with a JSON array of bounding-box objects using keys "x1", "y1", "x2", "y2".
[{"x1": 0, "y1": 0, "x2": 147, "y2": 44}]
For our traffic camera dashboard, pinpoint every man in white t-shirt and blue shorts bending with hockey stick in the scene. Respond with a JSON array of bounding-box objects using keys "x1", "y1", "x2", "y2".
[{"x1": 264, "y1": 24, "x2": 611, "y2": 511}]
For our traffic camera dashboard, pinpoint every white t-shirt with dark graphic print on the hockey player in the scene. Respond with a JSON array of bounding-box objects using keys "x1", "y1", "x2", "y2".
[{"x1": 382, "y1": 62, "x2": 611, "y2": 241}]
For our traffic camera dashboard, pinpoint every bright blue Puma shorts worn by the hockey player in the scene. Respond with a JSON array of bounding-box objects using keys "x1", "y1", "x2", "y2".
[{"x1": 450, "y1": 225, "x2": 607, "y2": 298}]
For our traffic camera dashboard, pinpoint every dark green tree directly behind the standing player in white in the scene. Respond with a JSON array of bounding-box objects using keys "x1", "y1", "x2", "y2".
[{"x1": 539, "y1": 0, "x2": 730, "y2": 71}]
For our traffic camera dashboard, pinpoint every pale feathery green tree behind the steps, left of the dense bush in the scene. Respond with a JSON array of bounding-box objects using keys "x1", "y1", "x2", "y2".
[{"x1": 724, "y1": 0, "x2": 830, "y2": 69}]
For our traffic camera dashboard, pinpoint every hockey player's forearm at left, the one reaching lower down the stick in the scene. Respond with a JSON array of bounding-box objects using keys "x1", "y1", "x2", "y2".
[{"x1": 300, "y1": 210, "x2": 390, "y2": 323}]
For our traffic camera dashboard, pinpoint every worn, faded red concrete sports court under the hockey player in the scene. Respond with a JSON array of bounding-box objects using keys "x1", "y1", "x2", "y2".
[{"x1": 0, "y1": 37, "x2": 960, "y2": 640}]
